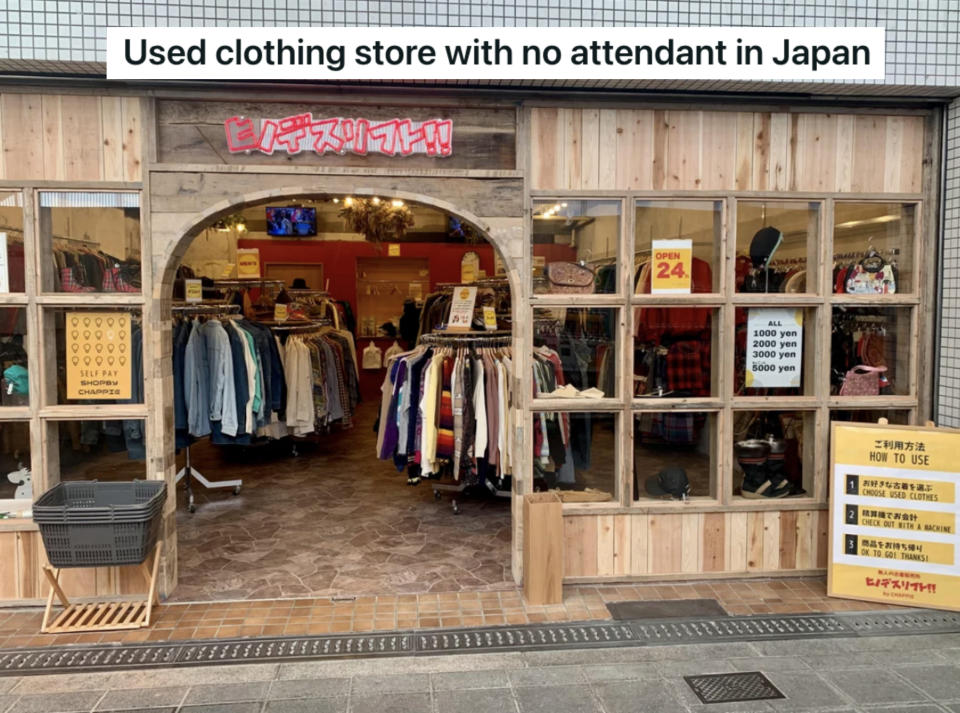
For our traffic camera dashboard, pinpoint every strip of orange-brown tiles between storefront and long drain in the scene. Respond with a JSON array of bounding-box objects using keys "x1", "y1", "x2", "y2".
[{"x1": 0, "y1": 578, "x2": 900, "y2": 648}]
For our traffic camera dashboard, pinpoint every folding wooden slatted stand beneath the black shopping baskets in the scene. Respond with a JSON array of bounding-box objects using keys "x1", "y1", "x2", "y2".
[{"x1": 40, "y1": 540, "x2": 163, "y2": 634}]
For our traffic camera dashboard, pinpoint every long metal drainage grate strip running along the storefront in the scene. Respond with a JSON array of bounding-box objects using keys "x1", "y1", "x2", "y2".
[{"x1": 0, "y1": 610, "x2": 960, "y2": 676}]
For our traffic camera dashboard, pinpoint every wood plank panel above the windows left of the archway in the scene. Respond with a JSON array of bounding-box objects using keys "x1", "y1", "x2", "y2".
[{"x1": 0, "y1": 92, "x2": 142, "y2": 181}]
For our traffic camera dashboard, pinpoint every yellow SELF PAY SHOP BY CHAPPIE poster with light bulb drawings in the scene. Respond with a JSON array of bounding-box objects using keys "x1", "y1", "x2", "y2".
[{"x1": 65, "y1": 312, "x2": 133, "y2": 401}]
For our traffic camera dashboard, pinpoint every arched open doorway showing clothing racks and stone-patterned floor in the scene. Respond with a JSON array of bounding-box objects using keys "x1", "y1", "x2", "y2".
[{"x1": 172, "y1": 195, "x2": 514, "y2": 601}]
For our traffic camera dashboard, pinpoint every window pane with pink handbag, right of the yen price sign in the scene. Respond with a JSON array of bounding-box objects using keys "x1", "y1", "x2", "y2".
[{"x1": 830, "y1": 306, "x2": 911, "y2": 396}]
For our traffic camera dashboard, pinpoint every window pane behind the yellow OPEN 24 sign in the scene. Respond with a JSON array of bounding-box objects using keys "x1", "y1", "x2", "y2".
[{"x1": 633, "y1": 201, "x2": 723, "y2": 295}]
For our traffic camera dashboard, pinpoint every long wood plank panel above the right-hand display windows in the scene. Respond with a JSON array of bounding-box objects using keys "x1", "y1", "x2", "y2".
[{"x1": 530, "y1": 108, "x2": 924, "y2": 193}]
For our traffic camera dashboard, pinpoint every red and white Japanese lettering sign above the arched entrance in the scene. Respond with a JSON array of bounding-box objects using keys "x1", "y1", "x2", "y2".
[{"x1": 223, "y1": 112, "x2": 453, "y2": 157}]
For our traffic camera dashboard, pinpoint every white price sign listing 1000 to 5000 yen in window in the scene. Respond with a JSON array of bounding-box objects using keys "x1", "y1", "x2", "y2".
[{"x1": 746, "y1": 307, "x2": 803, "y2": 389}]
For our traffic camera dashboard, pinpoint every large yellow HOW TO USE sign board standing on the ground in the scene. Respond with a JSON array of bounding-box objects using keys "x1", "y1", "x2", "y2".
[{"x1": 827, "y1": 423, "x2": 960, "y2": 610}]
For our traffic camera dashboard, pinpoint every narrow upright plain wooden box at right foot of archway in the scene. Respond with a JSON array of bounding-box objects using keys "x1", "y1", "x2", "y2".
[{"x1": 523, "y1": 493, "x2": 563, "y2": 605}]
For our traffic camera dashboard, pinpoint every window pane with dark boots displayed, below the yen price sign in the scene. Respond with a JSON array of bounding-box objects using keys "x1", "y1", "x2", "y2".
[{"x1": 732, "y1": 411, "x2": 816, "y2": 500}]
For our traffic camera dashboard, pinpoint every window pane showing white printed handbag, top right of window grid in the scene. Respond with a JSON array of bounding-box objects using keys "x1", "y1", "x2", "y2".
[{"x1": 831, "y1": 202, "x2": 917, "y2": 294}]
